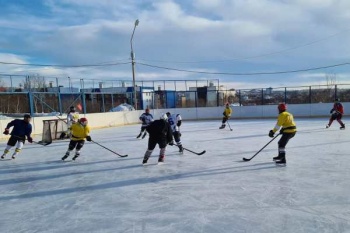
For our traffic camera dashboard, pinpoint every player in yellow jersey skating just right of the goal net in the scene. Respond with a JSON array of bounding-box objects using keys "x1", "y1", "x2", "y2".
[{"x1": 62, "y1": 117, "x2": 91, "y2": 160}]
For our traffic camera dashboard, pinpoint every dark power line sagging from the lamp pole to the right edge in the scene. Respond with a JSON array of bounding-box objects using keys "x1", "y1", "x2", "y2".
[{"x1": 137, "y1": 62, "x2": 350, "y2": 76}]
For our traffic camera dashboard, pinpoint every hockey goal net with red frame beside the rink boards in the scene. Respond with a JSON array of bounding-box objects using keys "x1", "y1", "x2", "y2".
[{"x1": 42, "y1": 119, "x2": 68, "y2": 143}]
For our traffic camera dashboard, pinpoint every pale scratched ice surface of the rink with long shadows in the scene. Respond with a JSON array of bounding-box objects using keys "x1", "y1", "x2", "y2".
[{"x1": 0, "y1": 118, "x2": 350, "y2": 233}]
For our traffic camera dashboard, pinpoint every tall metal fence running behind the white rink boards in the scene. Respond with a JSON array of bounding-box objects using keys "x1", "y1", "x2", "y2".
[{"x1": 0, "y1": 75, "x2": 350, "y2": 114}]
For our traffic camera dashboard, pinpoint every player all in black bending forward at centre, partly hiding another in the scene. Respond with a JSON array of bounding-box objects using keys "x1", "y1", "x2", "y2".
[{"x1": 142, "y1": 114, "x2": 174, "y2": 164}]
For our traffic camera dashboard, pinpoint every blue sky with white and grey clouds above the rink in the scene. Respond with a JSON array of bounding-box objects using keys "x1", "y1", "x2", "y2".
[{"x1": 0, "y1": 0, "x2": 350, "y2": 89}]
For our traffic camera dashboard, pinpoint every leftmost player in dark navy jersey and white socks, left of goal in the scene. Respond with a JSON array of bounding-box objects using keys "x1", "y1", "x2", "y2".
[{"x1": 1, "y1": 114, "x2": 33, "y2": 159}]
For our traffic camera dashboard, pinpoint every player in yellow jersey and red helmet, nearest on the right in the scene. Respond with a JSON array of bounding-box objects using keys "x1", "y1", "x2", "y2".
[{"x1": 269, "y1": 103, "x2": 297, "y2": 165}]
